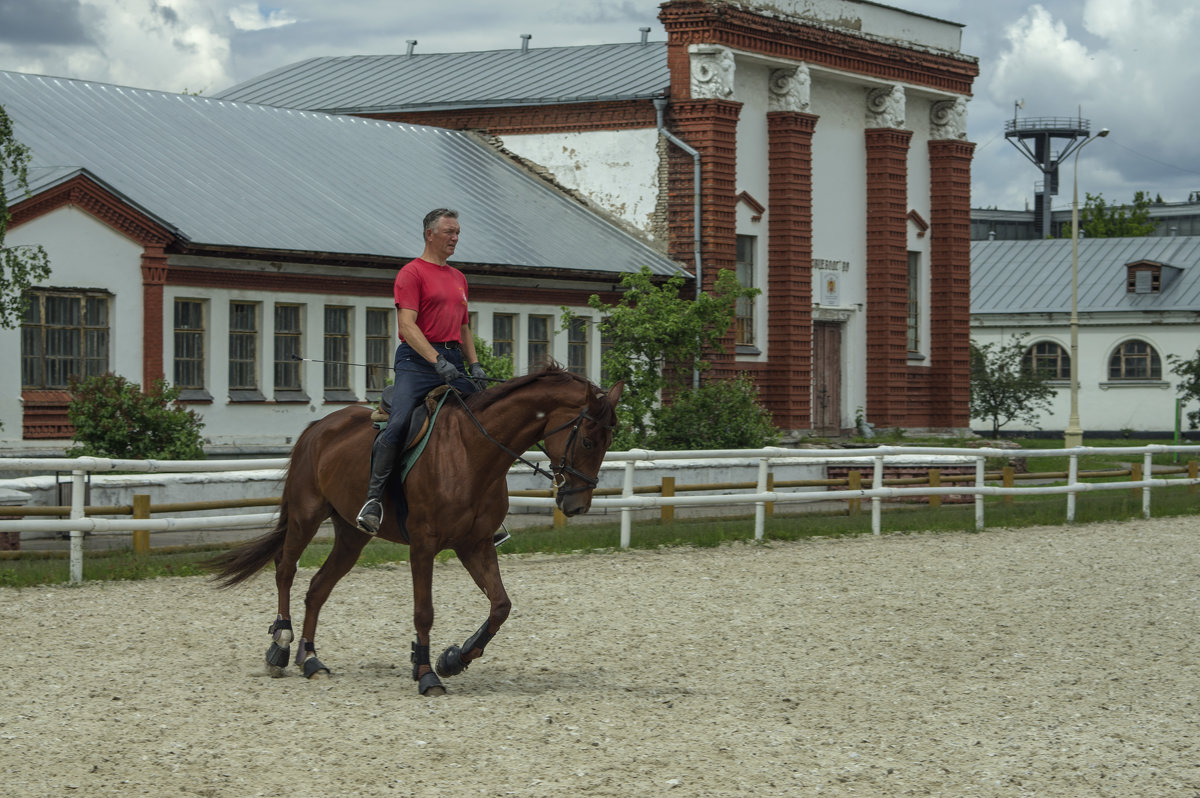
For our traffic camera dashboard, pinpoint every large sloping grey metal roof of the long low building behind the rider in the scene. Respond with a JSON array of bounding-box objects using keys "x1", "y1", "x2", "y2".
[{"x1": 0, "y1": 71, "x2": 683, "y2": 275}]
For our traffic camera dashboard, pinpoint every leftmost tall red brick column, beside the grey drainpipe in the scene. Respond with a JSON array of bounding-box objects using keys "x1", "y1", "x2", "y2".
[{"x1": 667, "y1": 100, "x2": 742, "y2": 377}]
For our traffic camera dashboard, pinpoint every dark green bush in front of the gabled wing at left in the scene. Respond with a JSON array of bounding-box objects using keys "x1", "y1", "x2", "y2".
[{"x1": 67, "y1": 373, "x2": 204, "y2": 460}]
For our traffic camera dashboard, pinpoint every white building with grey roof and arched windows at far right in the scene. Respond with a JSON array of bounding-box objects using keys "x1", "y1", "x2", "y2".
[{"x1": 971, "y1": 236, "x2": 1200, "y2": 443}]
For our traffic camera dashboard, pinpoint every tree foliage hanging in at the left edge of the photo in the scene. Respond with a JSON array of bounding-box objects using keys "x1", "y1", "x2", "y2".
[{"x1": 0, "y1": 106, "x2": 50, "y2": 329}]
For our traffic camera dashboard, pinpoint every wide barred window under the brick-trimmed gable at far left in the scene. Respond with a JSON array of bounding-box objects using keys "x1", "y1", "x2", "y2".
[{"x1": 20, "y1": 290, "x2": 112, "y2": 389}]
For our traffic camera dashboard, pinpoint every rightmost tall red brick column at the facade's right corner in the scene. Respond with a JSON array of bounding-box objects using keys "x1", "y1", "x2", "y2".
[{"x1": 929, "y1": 139, "x2": 974, "y2": 427}]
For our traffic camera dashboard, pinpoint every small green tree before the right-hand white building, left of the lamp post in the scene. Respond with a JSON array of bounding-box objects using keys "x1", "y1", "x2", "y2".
[{"x1": 971, "y1": 335, "x2": 1056, "y2": 438}]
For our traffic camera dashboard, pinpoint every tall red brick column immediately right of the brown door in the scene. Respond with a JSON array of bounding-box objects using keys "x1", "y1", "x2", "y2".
[{"x1": 866, "y1": 127, "x2": 912, "y2": 426}]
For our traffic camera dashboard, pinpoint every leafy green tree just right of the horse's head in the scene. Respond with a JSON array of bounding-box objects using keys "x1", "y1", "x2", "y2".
[{"x1": 563, "y1": 266, "x2": 758, "y2": 449}]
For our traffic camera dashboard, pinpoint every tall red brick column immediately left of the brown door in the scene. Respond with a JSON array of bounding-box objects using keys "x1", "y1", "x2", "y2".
[{"x1": 757, "y1": 112, "x2": 818, "y2": 430}]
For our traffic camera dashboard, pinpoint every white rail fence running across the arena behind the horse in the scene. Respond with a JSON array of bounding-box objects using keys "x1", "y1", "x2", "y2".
[{"x1": 0, "y1": 445, "x2": 1200, "y2": 582}]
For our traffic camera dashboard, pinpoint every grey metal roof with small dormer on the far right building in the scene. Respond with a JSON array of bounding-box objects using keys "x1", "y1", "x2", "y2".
[{"x1": 971, "y1": 235, "x2": 1200, "y2": 316}]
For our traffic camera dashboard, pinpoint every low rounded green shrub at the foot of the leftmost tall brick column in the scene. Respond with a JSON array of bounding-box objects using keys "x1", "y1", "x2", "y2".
[{"x1": 649, "y1": 376, "x2": 779, "y2": 449}]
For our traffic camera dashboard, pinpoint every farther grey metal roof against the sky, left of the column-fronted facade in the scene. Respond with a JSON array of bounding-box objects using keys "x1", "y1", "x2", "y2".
[{"x1": 217, "y1": 42, "x2": 671, "y2": 114}]
